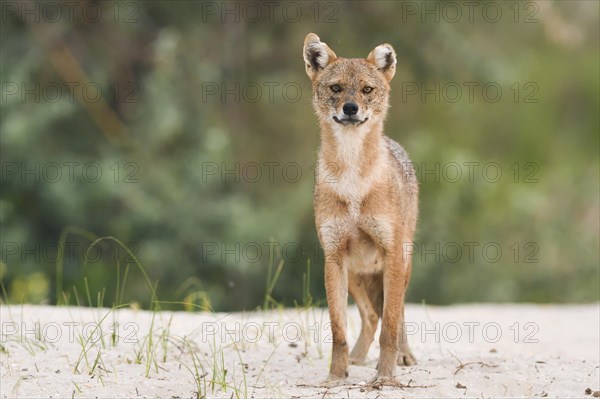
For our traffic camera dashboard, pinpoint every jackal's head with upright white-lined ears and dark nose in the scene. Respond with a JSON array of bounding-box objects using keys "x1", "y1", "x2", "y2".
[{"x1": 304, "y1": 33, "x2": 396, "y2": 128}]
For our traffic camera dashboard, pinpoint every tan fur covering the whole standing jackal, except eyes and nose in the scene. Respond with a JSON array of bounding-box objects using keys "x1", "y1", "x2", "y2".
[{"x1": 304, "y1": 33, "x2": 418, "y2": 379}]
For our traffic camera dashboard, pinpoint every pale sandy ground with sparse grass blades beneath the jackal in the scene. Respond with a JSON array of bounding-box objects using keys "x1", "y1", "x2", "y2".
[{"x1": 0, "y1": 304, "x2": 600, "y2": 398}]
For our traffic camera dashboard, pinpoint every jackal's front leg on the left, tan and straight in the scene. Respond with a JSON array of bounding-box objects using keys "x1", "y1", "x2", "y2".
[{"x1": 325, "y1": 255, "x2": 348, "y2": 379}]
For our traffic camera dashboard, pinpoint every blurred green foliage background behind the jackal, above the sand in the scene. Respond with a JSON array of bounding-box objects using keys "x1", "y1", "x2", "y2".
[{"x1": 0, "y1": 1, "x2": 600, "y2": 310}]
